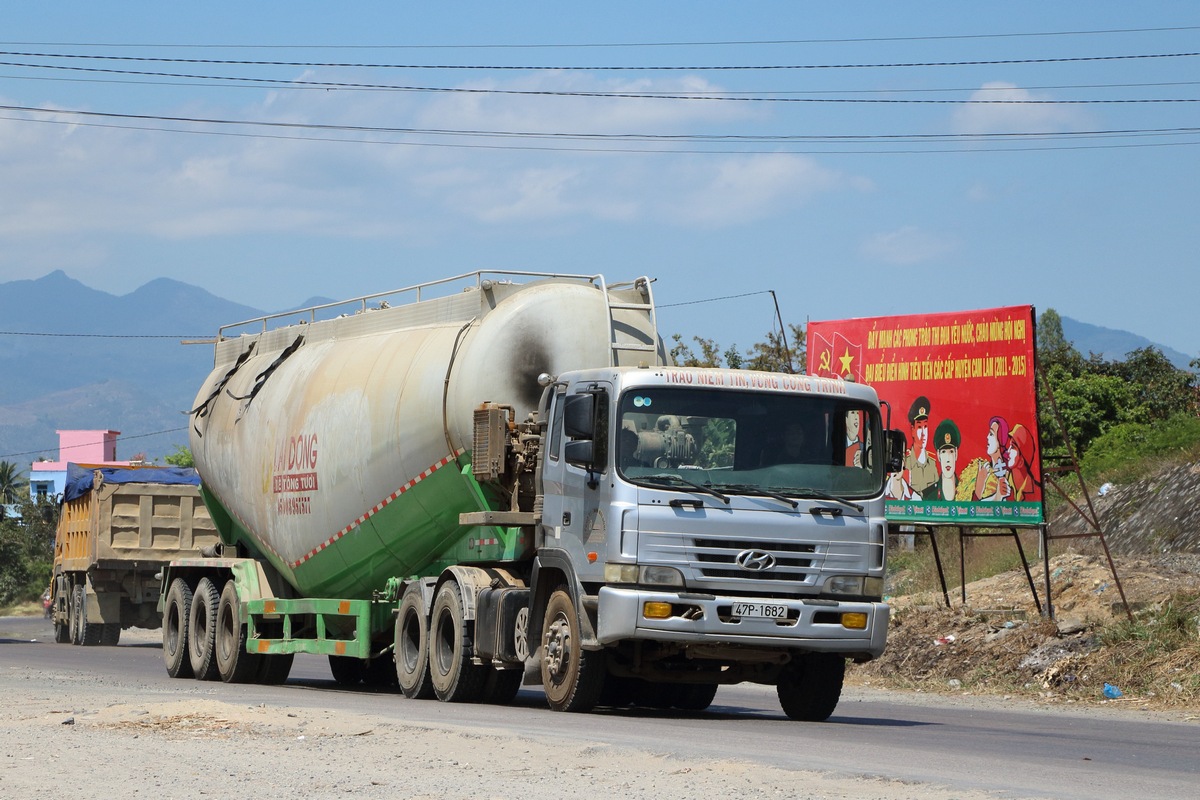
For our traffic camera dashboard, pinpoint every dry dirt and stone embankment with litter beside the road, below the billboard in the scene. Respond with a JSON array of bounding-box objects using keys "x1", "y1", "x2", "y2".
[{"x1": 850, "y1": 464, "x2": 1200, "y2": 720}]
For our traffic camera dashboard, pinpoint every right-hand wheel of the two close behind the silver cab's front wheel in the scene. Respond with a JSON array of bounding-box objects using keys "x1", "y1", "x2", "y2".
[{"x1": 428, "y1": 581, "x2": 487, "y2": 703}]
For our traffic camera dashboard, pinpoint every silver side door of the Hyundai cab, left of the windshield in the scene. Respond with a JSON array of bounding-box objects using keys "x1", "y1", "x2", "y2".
[{"x1": 541, "y1": 384, "x2": 612, "y2": 582}]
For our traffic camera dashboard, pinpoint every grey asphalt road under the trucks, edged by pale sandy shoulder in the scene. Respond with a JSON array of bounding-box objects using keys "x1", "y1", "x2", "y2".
[{"x1": 0, "y1": 618, "x2": 1200, "y2": 800}]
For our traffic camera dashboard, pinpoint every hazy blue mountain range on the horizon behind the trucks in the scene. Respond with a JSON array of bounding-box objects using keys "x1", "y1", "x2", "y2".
[{"x1": 0, "y1": 270, "x2": 1189, "y2": 467}]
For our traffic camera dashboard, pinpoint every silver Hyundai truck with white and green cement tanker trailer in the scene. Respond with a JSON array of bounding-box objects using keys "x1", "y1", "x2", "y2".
[{"x1": 160, "y1": 272, "x2": 904, "y2": 721}]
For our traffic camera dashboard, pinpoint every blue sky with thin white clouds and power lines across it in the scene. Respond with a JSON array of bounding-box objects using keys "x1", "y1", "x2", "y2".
[{"x1": 0, "y1": 1, "x2": 1200, "y2": 356}]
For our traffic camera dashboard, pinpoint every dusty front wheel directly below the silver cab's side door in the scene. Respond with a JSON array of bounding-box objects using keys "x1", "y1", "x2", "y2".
[{"x1": 541, "y1": 588, "x2": 605, "y2": 711}]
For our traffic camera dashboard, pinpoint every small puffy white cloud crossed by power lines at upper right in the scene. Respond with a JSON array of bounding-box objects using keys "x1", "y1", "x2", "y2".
[{"x1": 953, "y1": 80, "x2": 1087, "y2": 134}]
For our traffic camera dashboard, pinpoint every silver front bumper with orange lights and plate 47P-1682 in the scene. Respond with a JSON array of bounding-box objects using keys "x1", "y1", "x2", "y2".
[{"x1": 596, "y1": 587, "x2": 892, "y2": 658}]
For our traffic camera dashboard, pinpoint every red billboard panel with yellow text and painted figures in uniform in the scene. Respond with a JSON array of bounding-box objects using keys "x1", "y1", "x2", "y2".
[{"x1": 808, "y1": 306, "x2": 1044, "y2": 527}]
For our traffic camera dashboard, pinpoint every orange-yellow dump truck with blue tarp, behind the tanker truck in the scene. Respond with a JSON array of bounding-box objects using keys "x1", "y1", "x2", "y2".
[{"x1": 50, "y1": 463, "x2": 220, "y2": 645}]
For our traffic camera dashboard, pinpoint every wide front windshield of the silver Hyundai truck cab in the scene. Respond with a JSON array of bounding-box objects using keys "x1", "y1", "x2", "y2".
[{"x1": 616, "y1": 386, "x2": 886, "y2": 499}]
